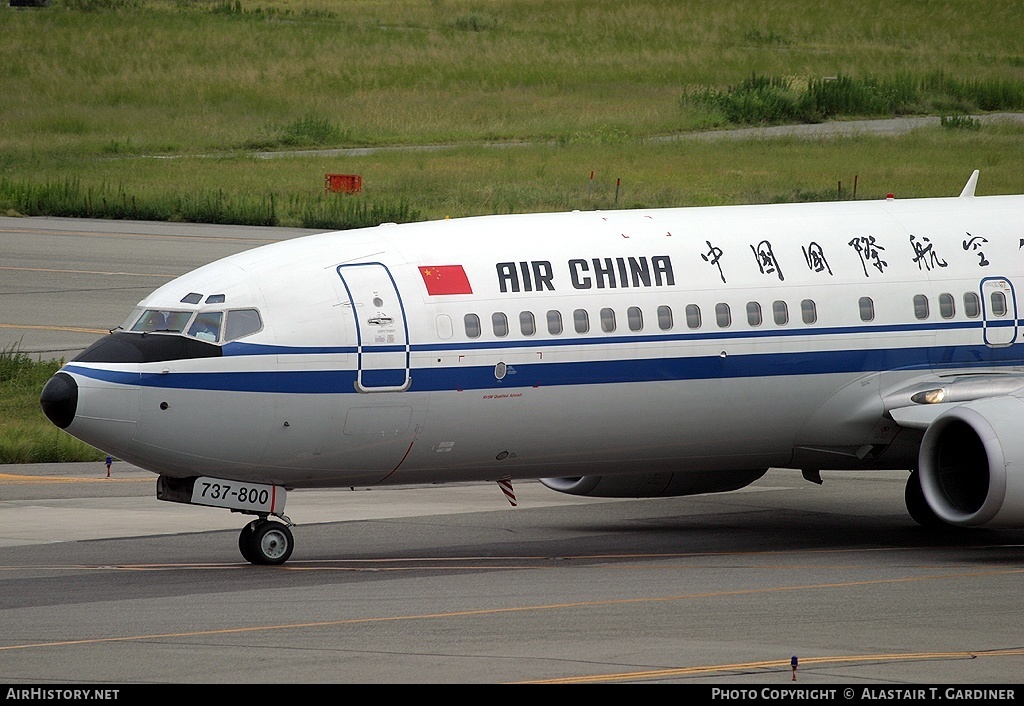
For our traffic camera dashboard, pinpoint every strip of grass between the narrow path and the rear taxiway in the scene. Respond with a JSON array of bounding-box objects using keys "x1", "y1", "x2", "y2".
[{"x1": 6, "y1": 125, "x2": 1024, "y2": 220}]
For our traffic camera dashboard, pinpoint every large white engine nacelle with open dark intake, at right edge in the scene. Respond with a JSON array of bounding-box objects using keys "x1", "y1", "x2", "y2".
[{"x1": 918, "y1": 397, "x2": 1024, "y2": 528}]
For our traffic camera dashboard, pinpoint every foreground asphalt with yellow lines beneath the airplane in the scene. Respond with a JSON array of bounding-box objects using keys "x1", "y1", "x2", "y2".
[{"x1": 0, "y1": 462, "x2": 1024, "y2": 684}]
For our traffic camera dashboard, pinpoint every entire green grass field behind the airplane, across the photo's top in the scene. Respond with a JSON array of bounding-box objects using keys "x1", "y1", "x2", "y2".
[{"x1": 0, "y1": 0, "x2": 1024, "y2": 227}]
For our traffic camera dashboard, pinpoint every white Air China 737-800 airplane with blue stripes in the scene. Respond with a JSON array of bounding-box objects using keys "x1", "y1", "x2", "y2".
[{"x1": 41, "y1": 172, "x2": 1024, "y2": 564}]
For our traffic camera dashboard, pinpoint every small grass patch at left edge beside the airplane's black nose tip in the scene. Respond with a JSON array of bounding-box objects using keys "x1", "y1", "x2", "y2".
[{"x1": 0, "y1": 346, "x2": 102, "y2": 463}]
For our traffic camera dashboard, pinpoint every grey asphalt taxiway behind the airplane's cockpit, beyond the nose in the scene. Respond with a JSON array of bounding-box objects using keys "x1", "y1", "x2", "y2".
[{"x1": 0, "y1": 216, "x2": 322, "y2": 360}]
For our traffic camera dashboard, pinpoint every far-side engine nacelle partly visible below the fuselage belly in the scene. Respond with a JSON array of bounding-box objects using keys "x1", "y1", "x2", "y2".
[{"x1": 541, "y1": 468, "x2": 768, "y2": 498}]
